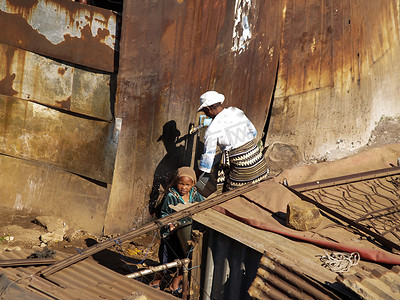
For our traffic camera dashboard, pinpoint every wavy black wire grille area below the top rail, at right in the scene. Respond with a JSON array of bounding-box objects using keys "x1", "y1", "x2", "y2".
[{"x1": 303, "y1": 175, "x2": 400, "y2": 245}]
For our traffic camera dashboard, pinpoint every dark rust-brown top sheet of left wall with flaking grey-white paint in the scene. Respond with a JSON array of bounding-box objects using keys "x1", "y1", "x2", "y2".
[{"x1": 0, "y1": 0, "x2": 118, "y2": 72}]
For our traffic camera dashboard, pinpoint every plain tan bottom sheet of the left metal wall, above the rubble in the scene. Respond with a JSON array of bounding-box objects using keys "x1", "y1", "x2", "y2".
[{"x1": 0, "y1": 155, "x2": 110, "y2": 234}]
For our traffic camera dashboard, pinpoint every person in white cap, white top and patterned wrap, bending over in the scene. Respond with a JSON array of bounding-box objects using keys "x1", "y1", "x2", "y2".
[{"x1": 198, "y1": 91, "x2": 269, "y2": 190}]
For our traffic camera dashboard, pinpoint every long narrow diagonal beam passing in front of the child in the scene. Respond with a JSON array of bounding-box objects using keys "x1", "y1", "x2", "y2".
[{"x1": 36, "y1": 184, "x2": 257, "y2": 277}]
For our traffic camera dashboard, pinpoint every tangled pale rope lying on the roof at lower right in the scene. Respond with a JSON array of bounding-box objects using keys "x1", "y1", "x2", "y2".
[{"x1": 320, "y1": 250, "x2": 360, "y2": 273}]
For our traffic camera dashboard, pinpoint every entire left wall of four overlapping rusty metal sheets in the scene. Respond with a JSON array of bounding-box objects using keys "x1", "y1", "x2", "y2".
[{"x1": 0, "y1": 0, "x2": 120, "y2": 234}]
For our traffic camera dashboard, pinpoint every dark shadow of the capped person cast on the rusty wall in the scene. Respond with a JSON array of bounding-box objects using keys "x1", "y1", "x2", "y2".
[{"x1": 149, "y1": 120, "x2": 197, "y2": 217}]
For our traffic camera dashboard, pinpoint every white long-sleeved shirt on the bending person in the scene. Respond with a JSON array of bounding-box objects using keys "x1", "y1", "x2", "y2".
[{"x1": 199, "y1": 107, "x2": 257, "y2": 173}]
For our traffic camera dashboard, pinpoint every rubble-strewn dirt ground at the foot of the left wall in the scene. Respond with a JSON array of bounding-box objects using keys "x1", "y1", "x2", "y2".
[{"x1": 0, "y1": 208, "x2": 160, "y2": 283}]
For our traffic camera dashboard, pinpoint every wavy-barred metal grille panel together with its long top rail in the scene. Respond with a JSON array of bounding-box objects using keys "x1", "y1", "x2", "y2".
[{"x1": 291, "y1": 167, "x2": 400, "y2": 250}]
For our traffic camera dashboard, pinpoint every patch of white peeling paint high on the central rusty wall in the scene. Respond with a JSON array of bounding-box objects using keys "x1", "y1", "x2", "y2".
[{"x1": 231, "y1": 0, "x2": 254, "y2": 55}]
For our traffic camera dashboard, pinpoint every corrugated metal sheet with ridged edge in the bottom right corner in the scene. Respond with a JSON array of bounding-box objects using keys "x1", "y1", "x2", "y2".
[{"x1": 338, "y1": 266, "x2": 400, "y2": 300}]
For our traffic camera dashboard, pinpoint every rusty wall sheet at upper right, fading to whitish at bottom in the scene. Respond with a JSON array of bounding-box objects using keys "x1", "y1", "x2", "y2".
[{"x1": 267, "y1": 0, "x2": 400, "y2": 160}]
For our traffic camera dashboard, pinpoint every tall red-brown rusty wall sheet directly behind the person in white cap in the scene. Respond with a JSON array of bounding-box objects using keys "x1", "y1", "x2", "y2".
[{"x1": 105, "y1": 0, "x2": 283, "y2": 232}]
